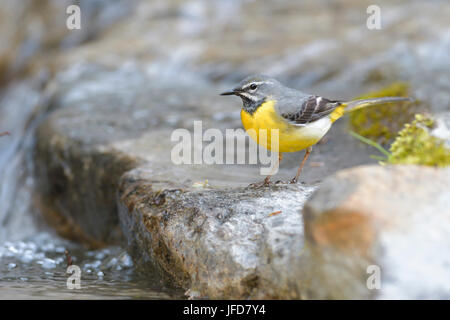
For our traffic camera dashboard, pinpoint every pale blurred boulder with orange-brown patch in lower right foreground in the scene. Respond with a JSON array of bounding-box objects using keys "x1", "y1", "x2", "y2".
[{"x1": 304, "y1": 166, "x2": 450, "y2": 299}]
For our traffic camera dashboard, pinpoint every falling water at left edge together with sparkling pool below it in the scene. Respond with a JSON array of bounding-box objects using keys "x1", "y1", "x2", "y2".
[{"x1": 0, "y1": 75, "x2": 184, "y2": 299}]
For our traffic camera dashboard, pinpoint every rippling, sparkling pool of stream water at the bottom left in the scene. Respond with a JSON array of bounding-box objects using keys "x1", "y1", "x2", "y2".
[{"x1": 0, "y1": 232, "x2": 183, "y2": 299}]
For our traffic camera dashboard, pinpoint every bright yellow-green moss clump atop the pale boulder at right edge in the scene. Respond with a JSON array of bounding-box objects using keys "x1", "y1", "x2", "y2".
[{"x1": 387, "y1": 114, "x2": 450, "y2": 167}]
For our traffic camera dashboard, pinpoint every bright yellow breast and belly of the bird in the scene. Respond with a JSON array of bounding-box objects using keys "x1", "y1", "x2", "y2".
[{"x1": 241, "y1": 100, "x2": 331, "y2": 152}]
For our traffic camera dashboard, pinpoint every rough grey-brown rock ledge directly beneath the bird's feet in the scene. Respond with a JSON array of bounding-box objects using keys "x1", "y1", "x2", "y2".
[{"x1": 118, "y1": 168, "x2": 315, "y2": 299}]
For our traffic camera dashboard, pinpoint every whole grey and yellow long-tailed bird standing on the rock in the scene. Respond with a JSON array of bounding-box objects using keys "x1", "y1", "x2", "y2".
[{"x1": 220, "y1": 75, "x2": 412, "y2": 185}]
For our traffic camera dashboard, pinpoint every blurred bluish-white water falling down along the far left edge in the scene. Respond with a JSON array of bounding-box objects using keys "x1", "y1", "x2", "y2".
[{"x1": 0, "y1": 72, "x2": 47, "y2": 242}]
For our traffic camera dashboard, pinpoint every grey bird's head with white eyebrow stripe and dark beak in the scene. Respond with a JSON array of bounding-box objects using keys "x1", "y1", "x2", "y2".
[{"x1": 221, "y1": 75, "x2": 286, "y2": 114}]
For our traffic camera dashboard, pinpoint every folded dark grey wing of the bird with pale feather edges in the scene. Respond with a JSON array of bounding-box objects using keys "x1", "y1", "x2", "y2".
[{"x1": 280, "y1": 96, "x2": 341, "y2": 125}]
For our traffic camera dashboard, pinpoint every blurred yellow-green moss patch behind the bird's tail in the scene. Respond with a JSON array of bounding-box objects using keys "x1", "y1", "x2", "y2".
[{"x1": 350, "y1": 82, "x2": 426, "y2": 144}]
